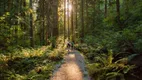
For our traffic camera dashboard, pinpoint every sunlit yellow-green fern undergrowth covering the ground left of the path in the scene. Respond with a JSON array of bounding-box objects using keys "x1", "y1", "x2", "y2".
[{"x1": 0, "y1": 46, "x2": 64, "y2": 80}]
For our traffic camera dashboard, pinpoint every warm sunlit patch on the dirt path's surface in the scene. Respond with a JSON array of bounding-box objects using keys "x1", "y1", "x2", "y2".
[{"x1": 51, "y1": 54, "x2": 83, "y2": 80}]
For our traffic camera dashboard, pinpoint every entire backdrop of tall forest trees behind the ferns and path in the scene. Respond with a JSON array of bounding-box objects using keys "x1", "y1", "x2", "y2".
[{"x1": 0, "y1": 0, "x2": 141, "y2": 52}]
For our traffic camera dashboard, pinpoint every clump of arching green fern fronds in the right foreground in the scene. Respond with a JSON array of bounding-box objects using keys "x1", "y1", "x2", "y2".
[{"x1": 87, "y1": 51, "x2": 134, "y2": 80}]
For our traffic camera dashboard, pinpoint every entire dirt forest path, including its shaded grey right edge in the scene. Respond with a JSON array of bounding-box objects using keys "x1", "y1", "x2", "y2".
[{"x1": 51, "y1": 50, "x2": 90, "y2": 80}]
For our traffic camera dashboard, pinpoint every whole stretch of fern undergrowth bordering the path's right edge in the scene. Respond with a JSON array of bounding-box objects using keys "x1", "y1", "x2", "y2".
[{"x1": 77, "y1": 44, "x2": 136, "y2": 80}]
